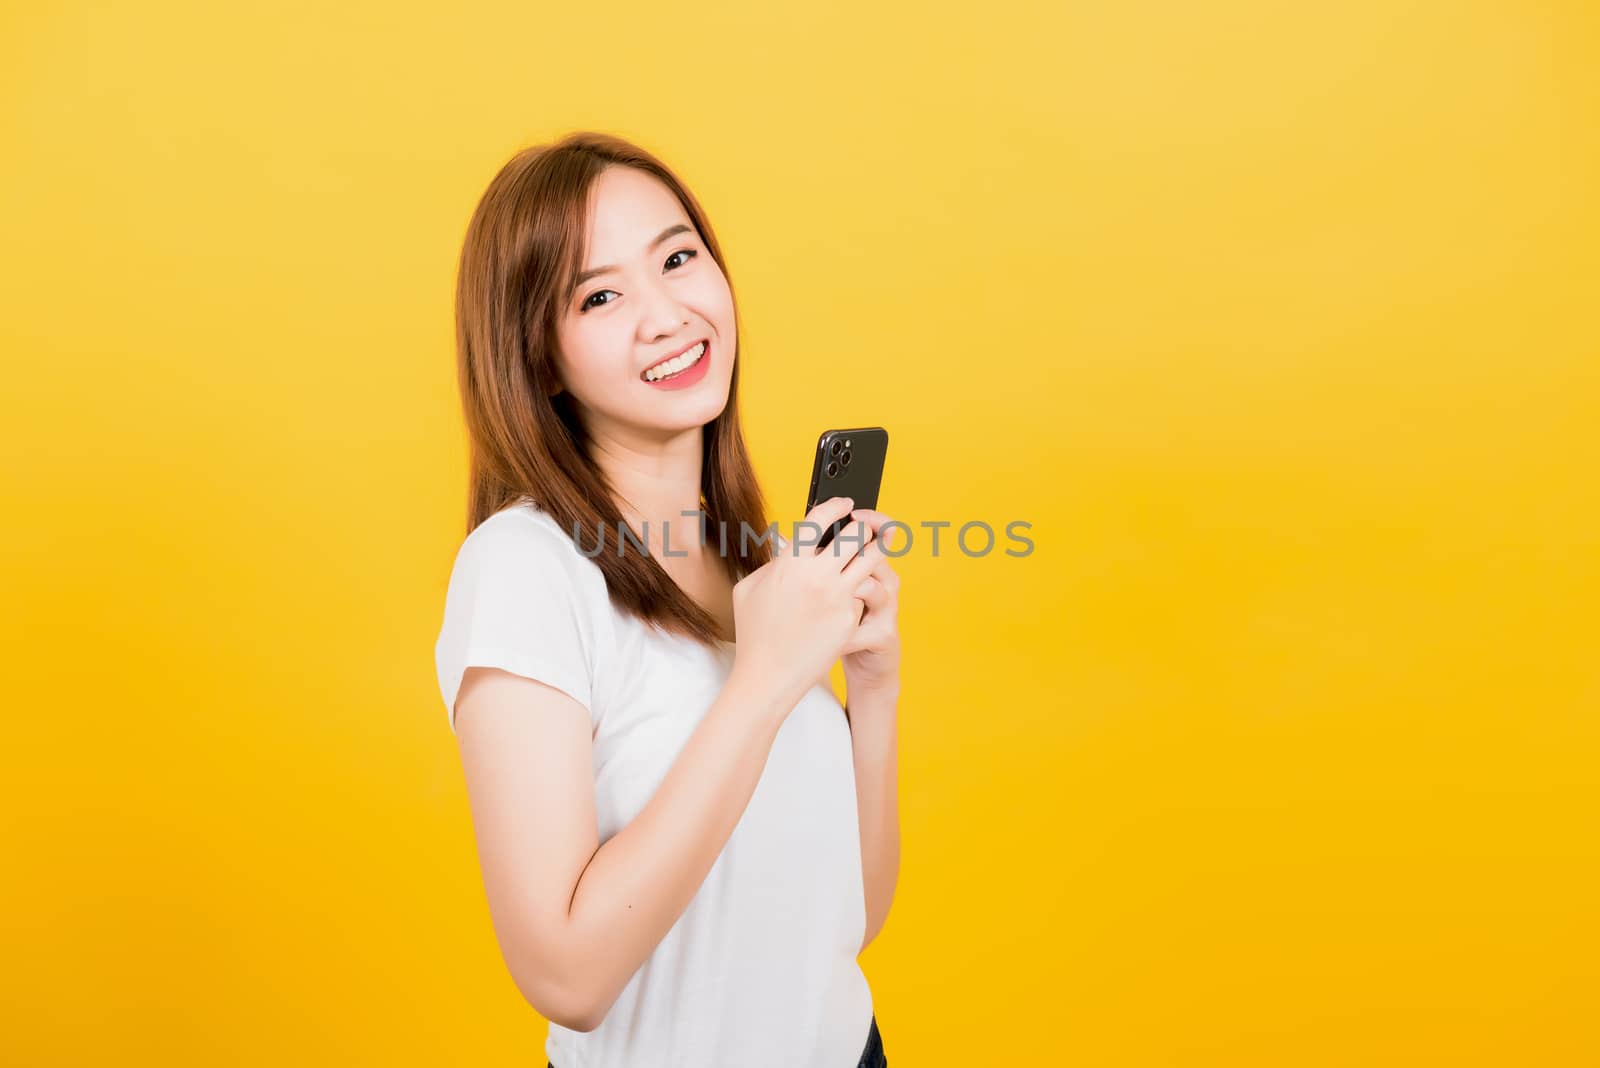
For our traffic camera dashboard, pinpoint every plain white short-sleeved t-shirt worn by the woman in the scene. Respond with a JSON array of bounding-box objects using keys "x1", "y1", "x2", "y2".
[{"x1": 435, "y1": 497, "x2": 874, "y2": 1068}]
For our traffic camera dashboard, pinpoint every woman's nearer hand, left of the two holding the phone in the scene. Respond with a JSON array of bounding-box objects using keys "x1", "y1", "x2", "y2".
[{"x1": 733, "y1": 497, "x2": 883, "y2": 716}]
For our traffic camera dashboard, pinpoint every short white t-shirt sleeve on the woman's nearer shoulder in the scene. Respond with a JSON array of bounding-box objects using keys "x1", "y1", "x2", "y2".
[{"x1": 434, "y1": 510, "x2": 603, "y2": 734}]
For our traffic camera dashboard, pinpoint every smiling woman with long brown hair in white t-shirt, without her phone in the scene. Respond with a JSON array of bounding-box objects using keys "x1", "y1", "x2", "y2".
[{"x1": 435, "y1": 133, "x2": 899, "y2": 1068}]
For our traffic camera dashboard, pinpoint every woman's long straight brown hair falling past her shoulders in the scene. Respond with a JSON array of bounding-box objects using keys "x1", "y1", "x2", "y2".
[{"x1": 456, "y1": 131, "x2": 771, "y2": 644}]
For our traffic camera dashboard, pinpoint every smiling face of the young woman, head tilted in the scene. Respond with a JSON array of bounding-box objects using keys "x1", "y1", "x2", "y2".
[{"x1": 555, "y1": 166, "x2": 738, "y2": 436}]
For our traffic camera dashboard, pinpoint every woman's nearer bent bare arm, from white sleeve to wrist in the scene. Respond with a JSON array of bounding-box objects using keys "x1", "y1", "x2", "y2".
[{"x1": 456, "y1": 667, "x2": 797, "y2": 1031}]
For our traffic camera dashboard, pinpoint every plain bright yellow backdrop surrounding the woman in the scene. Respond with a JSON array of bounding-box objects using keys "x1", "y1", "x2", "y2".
[{"x1": 0, "y1": 0, "x2": 1600, "y2": 1068}]
